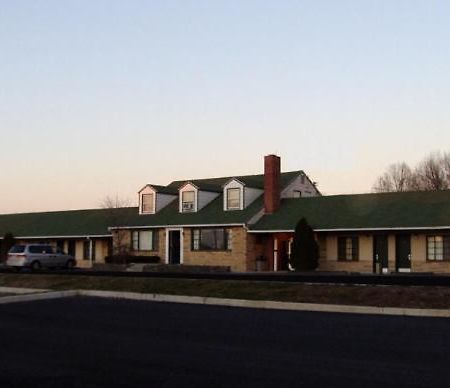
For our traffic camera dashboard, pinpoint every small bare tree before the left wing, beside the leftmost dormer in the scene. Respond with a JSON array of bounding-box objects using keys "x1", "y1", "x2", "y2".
[{"x1": 101, "y1": 195, "x2": 131, "y2": 255}]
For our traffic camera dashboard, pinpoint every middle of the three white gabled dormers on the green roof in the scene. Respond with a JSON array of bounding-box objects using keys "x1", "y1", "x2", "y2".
[{"x1": 178, "y1": 181, "x2": 220, "y2": 213}]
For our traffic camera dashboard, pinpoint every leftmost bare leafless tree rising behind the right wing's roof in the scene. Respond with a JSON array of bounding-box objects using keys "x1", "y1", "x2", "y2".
[{"x1": 373, "y1": 162, "x2": 415, "y2": 193}]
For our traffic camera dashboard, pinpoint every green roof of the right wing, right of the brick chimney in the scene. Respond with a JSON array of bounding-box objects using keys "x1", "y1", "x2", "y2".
[{"x1": 251, "y1": 190, "x2": 450, "y2": 231}]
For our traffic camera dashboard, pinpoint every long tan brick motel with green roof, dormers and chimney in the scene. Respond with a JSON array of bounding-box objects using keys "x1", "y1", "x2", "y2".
[{"x1": 0, "y1": 155, "x2": 450, "y2": 273}]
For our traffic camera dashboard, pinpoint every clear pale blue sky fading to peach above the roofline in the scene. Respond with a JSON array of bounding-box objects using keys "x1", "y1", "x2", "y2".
[{"x1": 0, "y1": 0, "x2": 450, "y2": 213}]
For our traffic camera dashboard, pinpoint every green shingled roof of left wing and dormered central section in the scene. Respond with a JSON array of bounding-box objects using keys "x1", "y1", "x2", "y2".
[{"x1": 0, "y1": 171, "x2": 301, "y2": 238}]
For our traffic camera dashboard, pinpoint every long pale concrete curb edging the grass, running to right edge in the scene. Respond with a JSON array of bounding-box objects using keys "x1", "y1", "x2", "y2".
[{"x1": 78, "y1": 290, "x2": 450, "y2": 318}]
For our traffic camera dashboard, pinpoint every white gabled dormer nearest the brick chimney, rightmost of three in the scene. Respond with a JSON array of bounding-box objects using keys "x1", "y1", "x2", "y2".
[{"x1": 223, "y1": 178, "x2": 264, "y2": 211}]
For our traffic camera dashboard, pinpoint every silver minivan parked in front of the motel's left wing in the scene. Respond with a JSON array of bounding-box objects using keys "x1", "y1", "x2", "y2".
[{"x1": 6, "y1": 244, "x2": 76, "y2": 270}]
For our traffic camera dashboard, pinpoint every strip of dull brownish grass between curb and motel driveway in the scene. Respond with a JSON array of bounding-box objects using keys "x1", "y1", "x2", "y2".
[{"x1": 0, "y1": 273, "x2": 450, "y2": 309}]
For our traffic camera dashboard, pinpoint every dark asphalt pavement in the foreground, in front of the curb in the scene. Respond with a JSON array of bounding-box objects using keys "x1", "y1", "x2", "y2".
[{"x1": 0, "y1": 297, "x2": 450, "y2": 388}]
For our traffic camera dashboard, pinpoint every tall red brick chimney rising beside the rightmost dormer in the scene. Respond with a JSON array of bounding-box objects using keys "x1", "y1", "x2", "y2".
[{"x1": 264, "y1": 155, "x2": 281, "y2": 214}]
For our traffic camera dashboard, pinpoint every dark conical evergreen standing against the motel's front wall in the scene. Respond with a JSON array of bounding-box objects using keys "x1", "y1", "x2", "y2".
[{"x1": 290, "y1": 218, "x2": 319, "y2": 271}]
